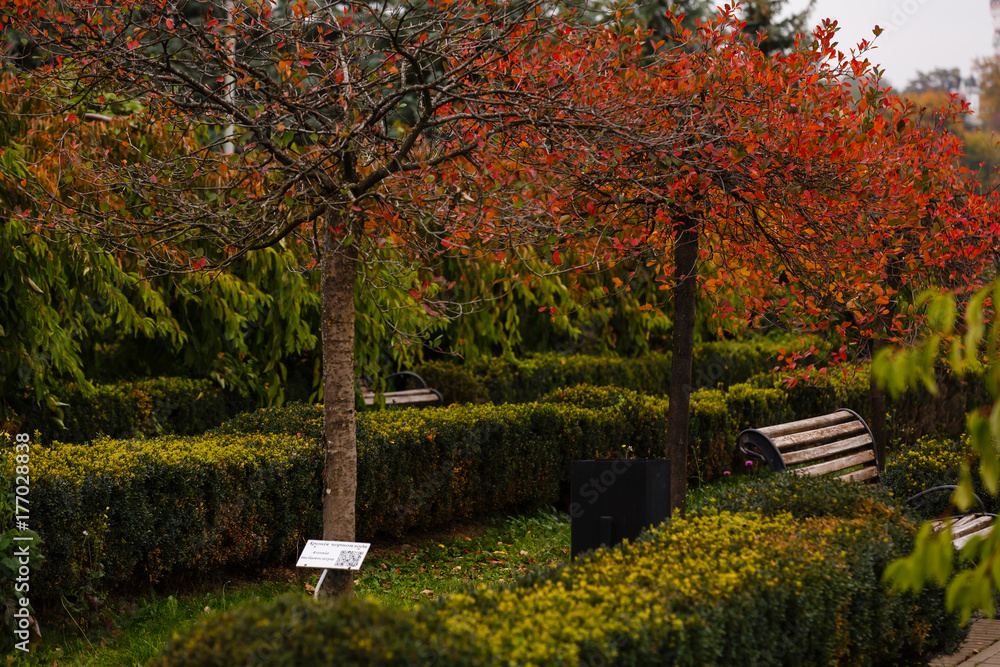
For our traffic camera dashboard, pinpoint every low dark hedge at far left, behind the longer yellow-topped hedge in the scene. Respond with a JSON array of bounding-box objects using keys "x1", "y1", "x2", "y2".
[{"x1": 13, "y1": 378, "x2": 255, "y2": 443}]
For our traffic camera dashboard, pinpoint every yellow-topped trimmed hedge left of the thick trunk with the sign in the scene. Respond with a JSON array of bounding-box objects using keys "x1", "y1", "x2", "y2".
[{"x1": 3, "y1": 435, "x2": 323, "y2": 599}]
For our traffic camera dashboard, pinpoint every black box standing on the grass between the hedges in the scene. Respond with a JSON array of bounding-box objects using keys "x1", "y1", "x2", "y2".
[{"x1": 569, "y1": 459, "x2": 671, "y2": 557}]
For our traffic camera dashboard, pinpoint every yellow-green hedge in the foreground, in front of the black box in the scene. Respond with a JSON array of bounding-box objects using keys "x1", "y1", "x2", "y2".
[{"x1": 153, "y1": 476, "x2": 963, "y2": 667}]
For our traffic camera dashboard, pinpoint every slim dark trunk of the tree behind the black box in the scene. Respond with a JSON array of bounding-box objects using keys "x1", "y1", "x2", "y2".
[{"x1": 667, "y1": 217, "x2": 698, "y2": 515}]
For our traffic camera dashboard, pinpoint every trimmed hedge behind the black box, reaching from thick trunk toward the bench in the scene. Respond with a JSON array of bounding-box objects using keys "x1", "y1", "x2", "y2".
[{"x1": 219, "y1": 385, "x2": 752, "y2": 506}]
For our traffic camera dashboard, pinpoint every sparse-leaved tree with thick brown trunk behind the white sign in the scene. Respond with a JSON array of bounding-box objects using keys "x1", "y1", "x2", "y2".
[{"x1": 0, "y1": 0, "x2": 712, "y2": 594}]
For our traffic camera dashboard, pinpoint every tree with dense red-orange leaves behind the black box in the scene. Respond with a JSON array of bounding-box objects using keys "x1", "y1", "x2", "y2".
[{"x1": 422, "y1": 8, "x2": 997, "y2": 508}]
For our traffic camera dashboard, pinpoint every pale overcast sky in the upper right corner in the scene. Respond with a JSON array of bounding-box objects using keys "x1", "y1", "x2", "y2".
[{"x1": 789, "y1": 0, "x2": 993, "y2": 90}]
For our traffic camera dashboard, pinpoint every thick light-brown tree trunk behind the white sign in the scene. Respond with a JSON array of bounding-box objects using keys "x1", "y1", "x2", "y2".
[{"x1": 319, "y1": 221, "x2": 358, "y2": 597}]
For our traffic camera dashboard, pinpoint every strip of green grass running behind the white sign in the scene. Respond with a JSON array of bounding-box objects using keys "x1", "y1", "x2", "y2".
[{"x1": 4, "y1": 510, "x2": 569, "y2": 667}]
